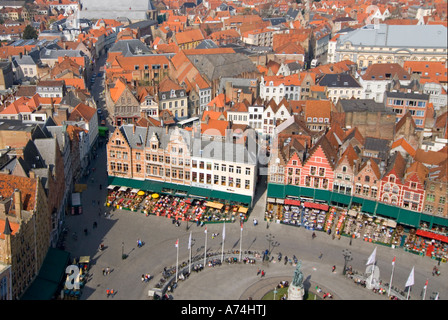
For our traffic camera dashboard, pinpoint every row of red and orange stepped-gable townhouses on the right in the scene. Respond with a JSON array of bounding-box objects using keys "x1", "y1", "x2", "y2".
[{"x1": 268, "y1": 122, "x2": 448, "y2": 216}]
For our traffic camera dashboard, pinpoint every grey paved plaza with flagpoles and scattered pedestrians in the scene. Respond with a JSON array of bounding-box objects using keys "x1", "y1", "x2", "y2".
[{"x1": 60, "y1": 146, "x2": 448, "y2": 300}]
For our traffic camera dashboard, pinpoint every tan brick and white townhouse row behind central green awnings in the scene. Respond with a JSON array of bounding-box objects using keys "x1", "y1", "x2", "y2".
[{"x1": 107, "y1": 124, "x2": 258, "y2": 205}]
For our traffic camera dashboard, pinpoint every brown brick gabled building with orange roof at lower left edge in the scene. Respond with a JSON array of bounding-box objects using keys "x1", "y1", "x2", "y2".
[{"x1": 0, "y1": 174, "x2": 51, "y2": 300}]
